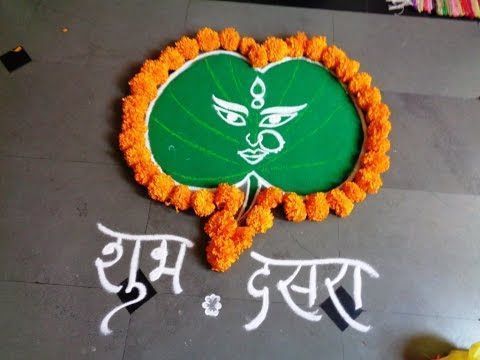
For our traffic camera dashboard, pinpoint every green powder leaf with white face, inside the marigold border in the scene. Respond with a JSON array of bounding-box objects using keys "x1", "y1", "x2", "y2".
[{"x1": 146, "y1": 51, "x2": 363, "y2": 207}]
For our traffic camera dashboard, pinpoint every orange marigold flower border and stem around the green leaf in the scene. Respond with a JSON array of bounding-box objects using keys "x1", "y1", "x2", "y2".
[{"x1": 119, "y1": 28, "x2": 391, "y2": 271}]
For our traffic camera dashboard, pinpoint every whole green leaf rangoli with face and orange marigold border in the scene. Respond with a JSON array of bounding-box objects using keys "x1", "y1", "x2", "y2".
[{"x1": 119, "y1": 28, "x2": 391, "y2": 271}]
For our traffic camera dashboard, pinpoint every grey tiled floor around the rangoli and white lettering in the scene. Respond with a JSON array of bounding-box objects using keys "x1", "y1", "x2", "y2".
[{"x1": 0, "y1": 0, "x2": 480, "y2": 360}]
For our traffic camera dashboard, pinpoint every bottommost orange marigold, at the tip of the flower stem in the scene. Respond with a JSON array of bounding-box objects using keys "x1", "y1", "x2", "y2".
[{"x1": 205, "y1": 237, "x2": 238, "y2": 272}]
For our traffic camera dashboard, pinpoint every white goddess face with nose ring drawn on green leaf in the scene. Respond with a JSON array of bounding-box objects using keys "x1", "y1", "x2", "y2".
[{"x1": 212, "y1": 76, "x2": 307, "y2": 165}]
